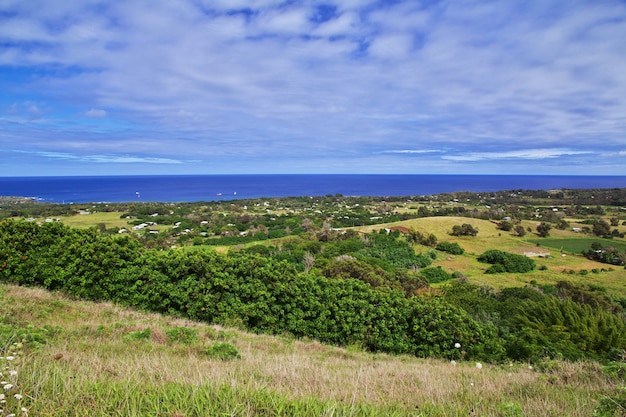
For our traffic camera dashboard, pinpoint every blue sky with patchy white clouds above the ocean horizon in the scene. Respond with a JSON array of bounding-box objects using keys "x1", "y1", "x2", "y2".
[{"x1": 0, "y1": 0, "x2": 626, "y2": 176}]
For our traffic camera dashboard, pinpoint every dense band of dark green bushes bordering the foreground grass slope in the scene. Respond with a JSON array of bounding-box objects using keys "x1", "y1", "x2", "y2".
[{"x1": 0, "y1": 220, "x2": 626, "y2": 361}]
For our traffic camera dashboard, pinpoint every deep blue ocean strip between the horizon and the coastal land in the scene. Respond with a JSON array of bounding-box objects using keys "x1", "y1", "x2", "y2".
[{"x1": 0, "y1": 174, "x2": 626, "y2": 204}]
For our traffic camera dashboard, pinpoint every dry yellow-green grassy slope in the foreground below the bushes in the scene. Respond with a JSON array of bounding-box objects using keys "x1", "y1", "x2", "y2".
[{"x1": 0, "y1": 285, "x2": 625, "y2": 417}]
